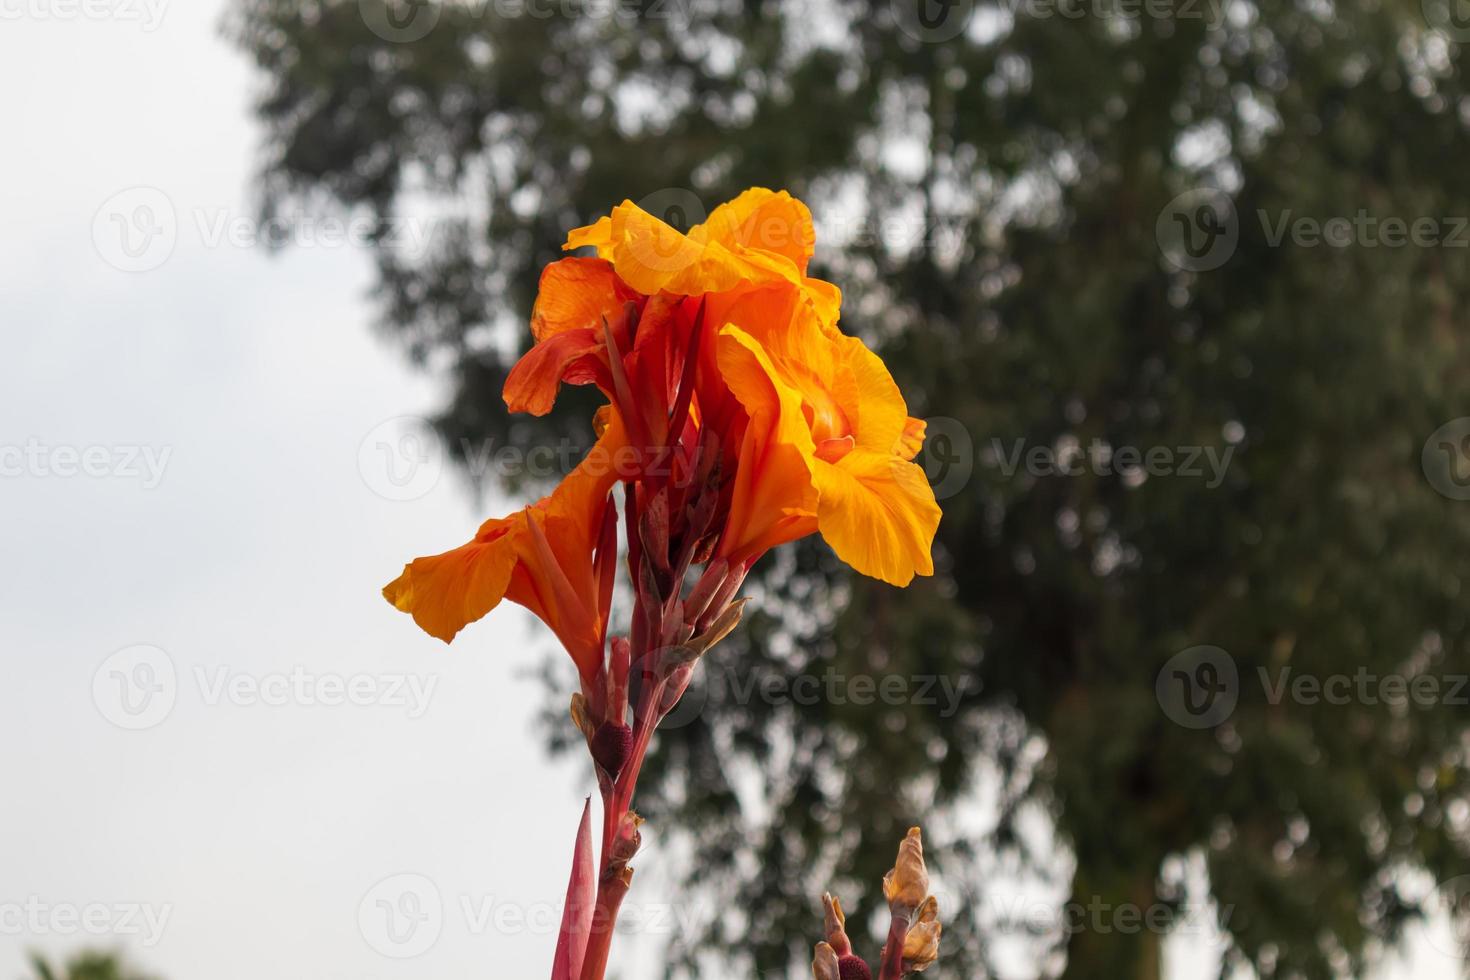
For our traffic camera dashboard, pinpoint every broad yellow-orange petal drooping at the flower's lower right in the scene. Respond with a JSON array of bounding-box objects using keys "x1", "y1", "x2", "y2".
[{"x1": 811, "y1": 450, "x2": 939, "y2": 586}]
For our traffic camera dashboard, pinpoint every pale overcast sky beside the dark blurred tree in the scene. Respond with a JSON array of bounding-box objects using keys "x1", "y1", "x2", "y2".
[{"x1": 0, "y1": 0, "x2": 1454, "y2": 980}]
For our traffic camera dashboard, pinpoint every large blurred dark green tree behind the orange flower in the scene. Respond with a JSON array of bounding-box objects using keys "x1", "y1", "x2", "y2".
[{"x1": 231, "y1": 0, "x2": 1470, "y2": 979}]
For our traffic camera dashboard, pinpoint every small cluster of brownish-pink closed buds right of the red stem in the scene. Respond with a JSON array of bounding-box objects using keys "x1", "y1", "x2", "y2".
[{"x1": 811, "y1": 827, "x2": 942, "y2": 980}]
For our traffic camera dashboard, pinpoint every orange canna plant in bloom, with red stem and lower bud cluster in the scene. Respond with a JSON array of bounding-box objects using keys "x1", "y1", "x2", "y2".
[{"x1": 384, "y1": 188, "x2": 939, "y2": 980}]
